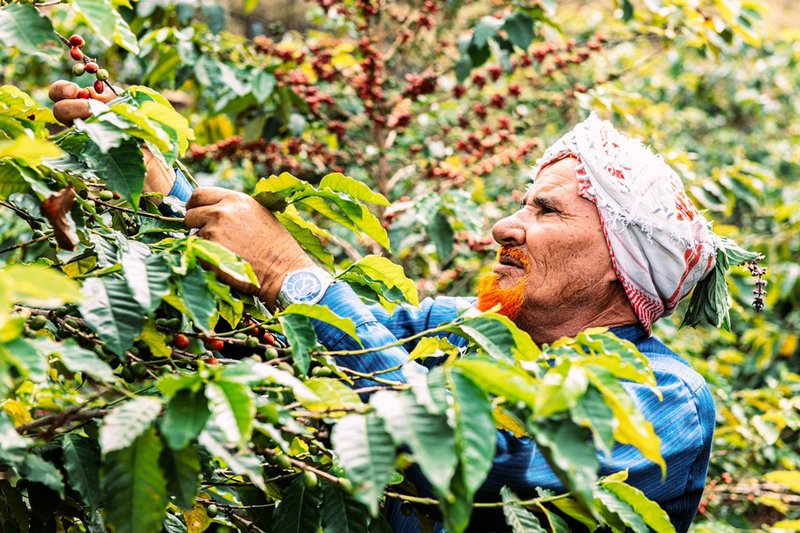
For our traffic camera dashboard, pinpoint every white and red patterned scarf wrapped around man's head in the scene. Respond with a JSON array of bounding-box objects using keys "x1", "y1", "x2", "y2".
[{"x1": 533, "y1": 113, "x2": 727, "y2": 330}]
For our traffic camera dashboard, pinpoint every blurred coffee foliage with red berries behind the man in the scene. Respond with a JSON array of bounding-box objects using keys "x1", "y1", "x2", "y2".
[{"x1": 0, "y1": 0, "x2": 800, "y2": 532}]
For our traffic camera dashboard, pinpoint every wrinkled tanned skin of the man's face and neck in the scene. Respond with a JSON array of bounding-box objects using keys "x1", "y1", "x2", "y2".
[{"x1": 478, "y1": 158, "x2": 637, "y2": 343}]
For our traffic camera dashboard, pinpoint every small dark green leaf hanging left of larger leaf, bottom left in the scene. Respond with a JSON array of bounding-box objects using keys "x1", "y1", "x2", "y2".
[{"x1": 61, "y1": 433, "x2": 103, "y2": 511}]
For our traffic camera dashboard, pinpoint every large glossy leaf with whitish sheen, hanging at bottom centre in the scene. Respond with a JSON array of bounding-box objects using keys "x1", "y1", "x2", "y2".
[{"x1": 370, "y1": 391, "x2": 458, "y2": 496}]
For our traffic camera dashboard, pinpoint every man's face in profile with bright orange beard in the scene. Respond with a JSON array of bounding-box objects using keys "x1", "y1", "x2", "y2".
[{"x1": 478, "y1": 158, "x2": 617, "y2": 329}]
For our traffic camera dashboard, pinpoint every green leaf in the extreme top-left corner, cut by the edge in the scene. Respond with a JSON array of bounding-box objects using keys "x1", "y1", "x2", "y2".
[{"x1": 0, "y1": 2, "x2": 62, "y2": 60}]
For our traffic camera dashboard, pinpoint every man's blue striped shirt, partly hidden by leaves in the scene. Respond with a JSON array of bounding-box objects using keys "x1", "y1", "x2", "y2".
[{"x1": 161, "y1": 171, "x2": 715, "y2": 533}]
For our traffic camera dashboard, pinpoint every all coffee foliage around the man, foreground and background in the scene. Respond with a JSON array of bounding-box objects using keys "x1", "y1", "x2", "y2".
[{"x1": 0, "y1": 0, "x2": 800, "y2": 531}]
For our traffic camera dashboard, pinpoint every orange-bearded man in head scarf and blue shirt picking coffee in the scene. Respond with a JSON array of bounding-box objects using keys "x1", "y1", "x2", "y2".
[{"x1": 51, "y1": 82, "x2": 752, "y2": 532}]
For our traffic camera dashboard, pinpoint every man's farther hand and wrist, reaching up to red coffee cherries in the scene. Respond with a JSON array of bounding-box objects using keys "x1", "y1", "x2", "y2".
[{"x1": 50, "y1": 80, "x2": 175, "y2": 200}]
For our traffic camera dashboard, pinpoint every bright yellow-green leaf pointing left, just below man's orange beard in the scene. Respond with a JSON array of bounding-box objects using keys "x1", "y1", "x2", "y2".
[{"x1": 455, "y1": 359, "x2": 536, "y2": 405}]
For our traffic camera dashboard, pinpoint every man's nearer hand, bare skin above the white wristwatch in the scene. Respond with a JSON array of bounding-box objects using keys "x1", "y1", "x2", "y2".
[{"x1": 184, "y1": 187, "x2": 314, "y2": 309}]
